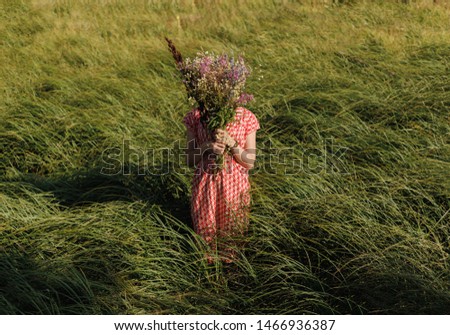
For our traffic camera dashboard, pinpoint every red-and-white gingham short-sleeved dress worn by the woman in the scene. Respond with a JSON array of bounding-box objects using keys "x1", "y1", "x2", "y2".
[{"x1": 183, "y1": 107, "x2": 260, "y2": 257}]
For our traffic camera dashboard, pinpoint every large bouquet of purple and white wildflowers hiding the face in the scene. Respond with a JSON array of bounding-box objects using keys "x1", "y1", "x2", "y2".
[{"x1": 166, "y1": 38, "x2": 253, "y2": 171}]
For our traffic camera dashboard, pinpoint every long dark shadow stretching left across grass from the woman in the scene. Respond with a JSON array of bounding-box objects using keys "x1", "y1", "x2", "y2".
[{"x1": 7, "y1": 168, "x2": 191, "y2": 224}]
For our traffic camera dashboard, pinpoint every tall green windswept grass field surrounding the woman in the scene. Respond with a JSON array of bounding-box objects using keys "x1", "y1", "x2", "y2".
[{"x1": 0, "y1": 0, "x2": 450, "y2": 314}]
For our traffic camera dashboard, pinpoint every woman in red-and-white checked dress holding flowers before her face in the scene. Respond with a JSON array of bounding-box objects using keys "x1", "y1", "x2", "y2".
[{"x1": 183, "y1": 107, "x2": 260, "y2": 263}]
